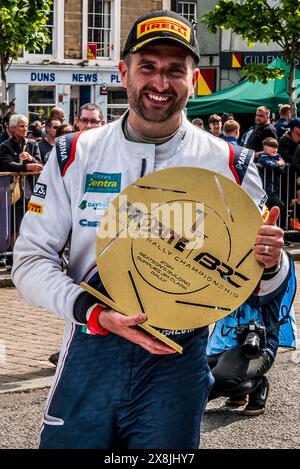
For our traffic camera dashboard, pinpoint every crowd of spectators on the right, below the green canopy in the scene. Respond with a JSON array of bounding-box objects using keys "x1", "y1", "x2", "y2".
[{"x1": 192, "y1": 104, "x2": 300, "y2": 231}]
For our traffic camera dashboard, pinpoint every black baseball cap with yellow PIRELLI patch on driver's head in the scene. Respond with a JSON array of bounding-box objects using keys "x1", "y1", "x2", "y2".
[{"x1": 123, "y1": 10, "x2": 200, "y2": 63}]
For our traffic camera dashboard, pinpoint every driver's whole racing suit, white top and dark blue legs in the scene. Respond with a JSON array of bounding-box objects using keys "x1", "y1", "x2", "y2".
[{"x1": 13, "y1": 114, "x2": 286, "y2": 448}]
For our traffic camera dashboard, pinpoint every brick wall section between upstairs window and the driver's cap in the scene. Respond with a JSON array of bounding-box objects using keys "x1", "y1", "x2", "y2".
[{"x1": 121, "y1": 0, "x2": 163, "y2": 51}]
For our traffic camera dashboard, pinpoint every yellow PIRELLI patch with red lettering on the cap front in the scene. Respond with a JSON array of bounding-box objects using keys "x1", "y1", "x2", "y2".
[{"x1": 137, "y1": 16, "x2": 191, "y2": 42}]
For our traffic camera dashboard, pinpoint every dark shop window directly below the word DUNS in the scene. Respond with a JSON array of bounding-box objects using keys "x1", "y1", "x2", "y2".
[{"x1": 28, "y1": 85, "x2": 56, "y2": 120}]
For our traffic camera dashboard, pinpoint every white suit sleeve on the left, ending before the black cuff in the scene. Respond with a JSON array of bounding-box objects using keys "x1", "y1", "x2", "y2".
[{"x1": 12, "y1": 146, "x2": 82, "y2": 322}]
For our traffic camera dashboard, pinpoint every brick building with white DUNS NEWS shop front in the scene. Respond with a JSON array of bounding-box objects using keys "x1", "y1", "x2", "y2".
[{"x1": 8, "y1": 0, "x2": 170, "y2": 122}]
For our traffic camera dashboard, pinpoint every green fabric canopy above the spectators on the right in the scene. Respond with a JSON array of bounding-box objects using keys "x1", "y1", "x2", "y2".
[{"x1": 187, "y1": 58, "x2": 300, "y2": 117}]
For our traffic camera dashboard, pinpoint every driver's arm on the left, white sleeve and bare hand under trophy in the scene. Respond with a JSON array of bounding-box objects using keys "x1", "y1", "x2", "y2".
[{"x1": 12, "y1": 146, "x2": 175, "y2": 354}]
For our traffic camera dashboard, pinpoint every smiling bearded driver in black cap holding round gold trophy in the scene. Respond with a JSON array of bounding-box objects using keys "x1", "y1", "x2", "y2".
[{"x1": 13, "y1": 10, "x2": 288, "y2": 449}]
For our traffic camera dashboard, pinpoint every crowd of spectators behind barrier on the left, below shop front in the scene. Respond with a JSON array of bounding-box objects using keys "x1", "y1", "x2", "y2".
[{"x1": 0, "y1": 103, "x2": 105, "y2": 269}]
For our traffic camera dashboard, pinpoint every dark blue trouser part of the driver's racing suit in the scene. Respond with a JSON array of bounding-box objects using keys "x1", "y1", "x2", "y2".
[{"x1": 40, "y1": 326, "x2": 213, "y2": 449}]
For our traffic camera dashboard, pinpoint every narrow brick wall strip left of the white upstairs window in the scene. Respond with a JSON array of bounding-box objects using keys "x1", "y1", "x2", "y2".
[{"x1": 65, "y1": 0, "x2": 82, "y2": 59}]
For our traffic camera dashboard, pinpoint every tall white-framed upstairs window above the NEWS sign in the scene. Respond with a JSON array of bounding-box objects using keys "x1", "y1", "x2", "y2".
[{"x1": 88, "y1": 0, "x2": 112, "y2": 58}]
